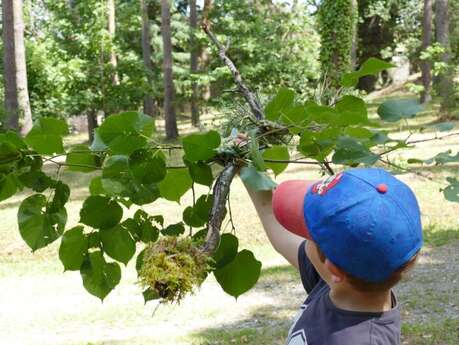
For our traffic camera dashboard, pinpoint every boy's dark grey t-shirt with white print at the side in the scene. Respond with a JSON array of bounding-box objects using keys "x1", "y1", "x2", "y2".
[{"x1": 287, "y1": 241, "x2": 400, "y2": 345}]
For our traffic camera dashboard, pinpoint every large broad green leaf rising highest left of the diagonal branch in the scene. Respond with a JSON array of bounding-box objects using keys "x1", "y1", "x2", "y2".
[{"x1": 97, "y1": 111, "x2": 155, "y2": 146}]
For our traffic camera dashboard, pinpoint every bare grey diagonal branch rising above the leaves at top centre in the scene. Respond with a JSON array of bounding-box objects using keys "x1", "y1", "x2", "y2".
[{"x1": 202, "y1": 23, "x2": 264, "y2": 120}]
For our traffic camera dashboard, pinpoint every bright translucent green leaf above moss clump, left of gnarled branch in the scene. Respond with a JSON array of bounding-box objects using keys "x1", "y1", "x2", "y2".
[{"x1": 159, "y1": 169, "x2": 193, "y2": 203}]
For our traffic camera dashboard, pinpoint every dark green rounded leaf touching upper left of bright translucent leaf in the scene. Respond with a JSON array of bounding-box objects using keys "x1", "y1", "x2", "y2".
[{"x1": 129, "y1": 150, "x2": 166, "y2": 184}]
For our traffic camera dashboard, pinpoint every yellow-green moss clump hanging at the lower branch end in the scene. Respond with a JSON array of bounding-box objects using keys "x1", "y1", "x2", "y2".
[{"x1": 139, "y1": 237, "x2": 212, "y2": 302}]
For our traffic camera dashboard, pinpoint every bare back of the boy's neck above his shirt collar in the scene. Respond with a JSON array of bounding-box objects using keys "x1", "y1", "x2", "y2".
[{"x1": 330, "y1": 286, "x2": 392, "y2": 313}]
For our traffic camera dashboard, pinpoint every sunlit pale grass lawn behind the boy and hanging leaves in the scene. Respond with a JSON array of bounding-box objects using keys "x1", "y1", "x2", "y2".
[{"x1": 0, "y1": 101, "x2": 459, "y2": 345}]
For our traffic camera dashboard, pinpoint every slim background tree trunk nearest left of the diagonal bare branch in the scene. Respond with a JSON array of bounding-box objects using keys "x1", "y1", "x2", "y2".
[{"x1": 190, "y1": 0, "x2": 199, "y2": 127}]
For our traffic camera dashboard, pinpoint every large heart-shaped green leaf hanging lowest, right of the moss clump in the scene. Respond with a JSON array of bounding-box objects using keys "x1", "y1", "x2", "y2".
[{"x1": 214, "y1": 249, "x2": 261, "y2": 298}]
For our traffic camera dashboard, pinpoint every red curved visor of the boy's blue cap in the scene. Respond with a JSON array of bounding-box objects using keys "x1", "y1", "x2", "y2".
[{"x1": 272, "y1": 180, "x2": 317, "y2": 239}]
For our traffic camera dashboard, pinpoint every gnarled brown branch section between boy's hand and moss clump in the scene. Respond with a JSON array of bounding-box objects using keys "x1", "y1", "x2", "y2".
[{"x1": 201, "y1": 162, "x2": 238, "y2": 254}]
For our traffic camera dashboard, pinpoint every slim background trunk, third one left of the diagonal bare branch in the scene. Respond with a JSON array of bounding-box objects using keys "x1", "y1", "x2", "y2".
[{"x1": 140, "y1": 0, "x2": 156, "y2": 117}]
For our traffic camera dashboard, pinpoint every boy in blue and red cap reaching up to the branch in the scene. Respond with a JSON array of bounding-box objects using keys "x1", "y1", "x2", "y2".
[{"x1": 247, "y1": 168, "x2": 422, "y2": 345}]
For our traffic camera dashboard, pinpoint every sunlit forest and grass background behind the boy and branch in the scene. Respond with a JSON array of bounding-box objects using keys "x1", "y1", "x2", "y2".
[{"x1": 0, "y1": 0, "x2": 459, "y2": 344}]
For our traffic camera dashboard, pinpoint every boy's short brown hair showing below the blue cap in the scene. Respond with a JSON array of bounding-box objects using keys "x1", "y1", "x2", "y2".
[{"x1": 316, "y1": 243, "x2": 419, "y2": 292}]
